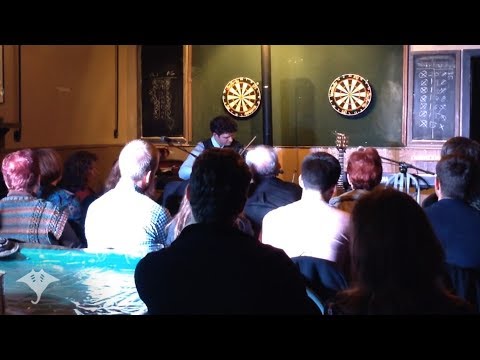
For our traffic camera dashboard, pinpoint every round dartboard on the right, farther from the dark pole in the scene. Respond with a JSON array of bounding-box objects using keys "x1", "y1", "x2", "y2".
[{"x1": 328, "y1": 74, "x2": 372, "y2": 116}]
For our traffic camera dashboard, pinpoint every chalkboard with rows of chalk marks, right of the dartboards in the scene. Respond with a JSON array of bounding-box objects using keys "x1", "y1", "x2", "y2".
[{"x1": 409, "y1": 52, "x2": 459, "y2": 142}]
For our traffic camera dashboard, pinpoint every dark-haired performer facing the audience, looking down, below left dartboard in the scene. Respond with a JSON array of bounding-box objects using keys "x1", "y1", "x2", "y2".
[{"x1": 178, "y1": 115, "x2": 242, "y2": 180}]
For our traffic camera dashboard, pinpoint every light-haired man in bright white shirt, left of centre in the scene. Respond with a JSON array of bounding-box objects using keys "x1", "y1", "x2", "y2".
[{"x1": 85, "y1": 140, "x2": 171, "y2": 256}]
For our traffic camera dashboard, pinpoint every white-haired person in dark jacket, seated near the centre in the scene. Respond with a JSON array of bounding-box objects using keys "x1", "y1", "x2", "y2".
[{"x1": 244, "y1": 145, "x2": 302, "y2": 238}]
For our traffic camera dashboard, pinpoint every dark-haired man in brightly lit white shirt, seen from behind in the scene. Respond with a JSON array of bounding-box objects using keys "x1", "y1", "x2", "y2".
[{"x1": 262, "y1": 151, "x2": 350, "y2": 273}]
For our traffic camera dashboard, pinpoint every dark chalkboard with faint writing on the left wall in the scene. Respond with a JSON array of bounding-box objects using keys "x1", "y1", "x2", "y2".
[{"x1": 140, "y1": 45, "x2": 184, "y2": 137}]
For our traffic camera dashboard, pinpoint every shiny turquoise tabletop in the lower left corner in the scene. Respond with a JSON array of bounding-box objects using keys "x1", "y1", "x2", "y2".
[{"x1": 0, "y1": 247, "x2": 147, "y2": 315}]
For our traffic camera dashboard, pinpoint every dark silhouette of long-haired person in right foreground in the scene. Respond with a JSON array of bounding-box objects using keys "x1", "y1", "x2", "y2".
[{"x1": 327, "y1": 188, "x2": 473, "y2": 315}]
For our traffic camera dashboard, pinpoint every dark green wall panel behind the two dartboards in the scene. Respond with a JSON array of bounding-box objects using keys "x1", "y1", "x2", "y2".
[{"x1": 192, "y1": 45, "x2": 403, "y2": 147}]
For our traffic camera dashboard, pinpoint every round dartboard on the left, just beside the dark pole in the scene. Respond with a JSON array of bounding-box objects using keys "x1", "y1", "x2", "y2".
[{"x1": 222, "y1": 77, "x2": 261, "y2": 117}]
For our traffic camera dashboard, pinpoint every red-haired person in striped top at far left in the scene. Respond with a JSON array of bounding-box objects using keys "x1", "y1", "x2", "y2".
[{"x1": 0, "y1": 149, "x2": 81, "y2": 248}]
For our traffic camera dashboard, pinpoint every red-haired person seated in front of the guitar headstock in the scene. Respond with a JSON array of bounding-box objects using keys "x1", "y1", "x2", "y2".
[{"x1": 329, "y1": 147, "x2": 383, "y2": 213}]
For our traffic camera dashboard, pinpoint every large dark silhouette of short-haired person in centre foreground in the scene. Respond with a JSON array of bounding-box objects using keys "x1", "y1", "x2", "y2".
[{"x1": 135, "y1": 148, "x2": 318, "y2": 314}]
